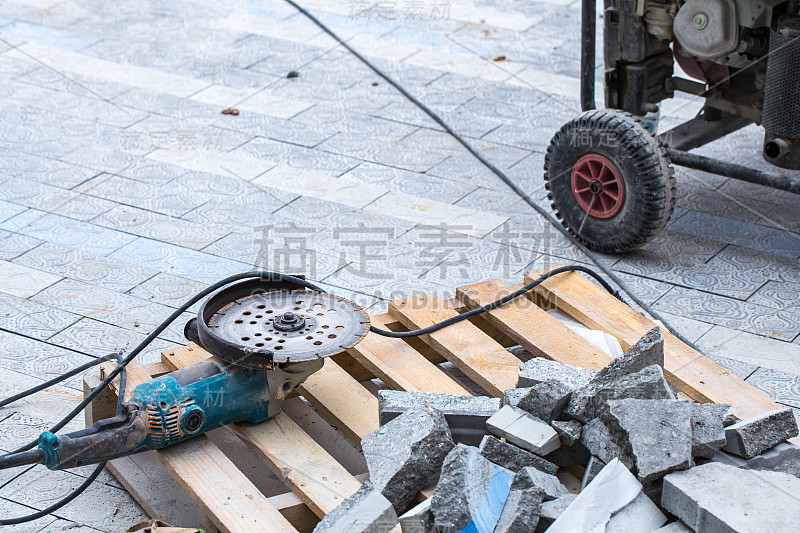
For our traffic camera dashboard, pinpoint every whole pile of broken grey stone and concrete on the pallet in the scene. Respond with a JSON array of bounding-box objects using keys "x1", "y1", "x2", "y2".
[{"x1": 314, "y1": 329, "x2": 800, "y2": 533}]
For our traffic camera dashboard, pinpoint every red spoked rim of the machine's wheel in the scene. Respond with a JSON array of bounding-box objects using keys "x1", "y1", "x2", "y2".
[{"x1": 572, "y1": 154, "x2": 625, "y2": 218}]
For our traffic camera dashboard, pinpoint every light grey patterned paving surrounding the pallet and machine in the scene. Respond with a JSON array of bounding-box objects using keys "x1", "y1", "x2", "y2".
[{"x1": 0, "y1": 0, "x2": 800, "y2": 532}]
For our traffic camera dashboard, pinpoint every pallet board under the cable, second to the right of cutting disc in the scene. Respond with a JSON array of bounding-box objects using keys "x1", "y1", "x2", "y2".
[{"x1": 389, "y1": 294, "x2": 520, "y2": 397}]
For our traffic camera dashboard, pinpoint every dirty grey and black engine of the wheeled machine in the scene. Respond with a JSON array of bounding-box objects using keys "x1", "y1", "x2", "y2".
[{"x1": 604, "y1": 0, "x2": 800, "y2": 169}]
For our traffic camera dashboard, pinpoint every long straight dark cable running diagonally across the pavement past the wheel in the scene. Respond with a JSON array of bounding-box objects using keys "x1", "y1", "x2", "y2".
[{"x1": 284, "y1": 0, "x2": 703, "y2": 353}]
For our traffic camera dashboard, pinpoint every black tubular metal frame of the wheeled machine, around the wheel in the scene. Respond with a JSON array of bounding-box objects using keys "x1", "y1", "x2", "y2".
[{"x1": 581, "y1": 0, "x2": 800, "y2": 194}]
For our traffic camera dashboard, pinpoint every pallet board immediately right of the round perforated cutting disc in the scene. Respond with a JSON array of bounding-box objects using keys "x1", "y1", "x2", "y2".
[{"x1": 348, "y1": 316, "x2": 470, "y2": 396}]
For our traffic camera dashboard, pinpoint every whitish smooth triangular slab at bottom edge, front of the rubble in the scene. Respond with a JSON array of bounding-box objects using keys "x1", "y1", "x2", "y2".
[{"x1": 547, "y1": 459, "x2": 667, "y2": 533}]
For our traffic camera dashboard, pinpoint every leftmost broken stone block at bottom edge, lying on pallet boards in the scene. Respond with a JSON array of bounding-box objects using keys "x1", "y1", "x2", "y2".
[{"x1": 314, "y1": 481, "x2": 397, "y2": 533}]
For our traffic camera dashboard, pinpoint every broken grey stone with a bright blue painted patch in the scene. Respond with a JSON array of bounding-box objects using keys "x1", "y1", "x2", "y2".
[{"x1": 431, "y1": 444, "x2": 514, "y2": 531}]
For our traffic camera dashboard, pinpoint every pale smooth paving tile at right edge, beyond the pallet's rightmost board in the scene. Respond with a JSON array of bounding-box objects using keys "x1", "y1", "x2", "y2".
[{"x1": 697, "y1": 326, "x2": 800, "y2": 375}]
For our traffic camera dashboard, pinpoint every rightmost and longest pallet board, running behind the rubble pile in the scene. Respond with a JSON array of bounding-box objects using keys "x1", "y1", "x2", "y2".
[{"x1": 525, "y1": 270, "x2": 800, "y2": 442}]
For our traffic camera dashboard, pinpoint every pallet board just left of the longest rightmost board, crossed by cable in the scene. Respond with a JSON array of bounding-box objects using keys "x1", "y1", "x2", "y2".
[{"x1": 456, "y1": 279, "x2": 611, "y2": 368}]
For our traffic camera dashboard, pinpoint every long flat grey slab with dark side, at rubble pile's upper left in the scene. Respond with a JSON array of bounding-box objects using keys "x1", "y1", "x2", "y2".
[{"x1": 378, "y1": 390, "x2": 501, "y2": 446}]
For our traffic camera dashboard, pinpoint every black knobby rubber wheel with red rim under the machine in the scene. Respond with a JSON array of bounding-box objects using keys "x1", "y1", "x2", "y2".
[{"x1": 544, "y1": 109, "x2": 675, "y2": 253}]
